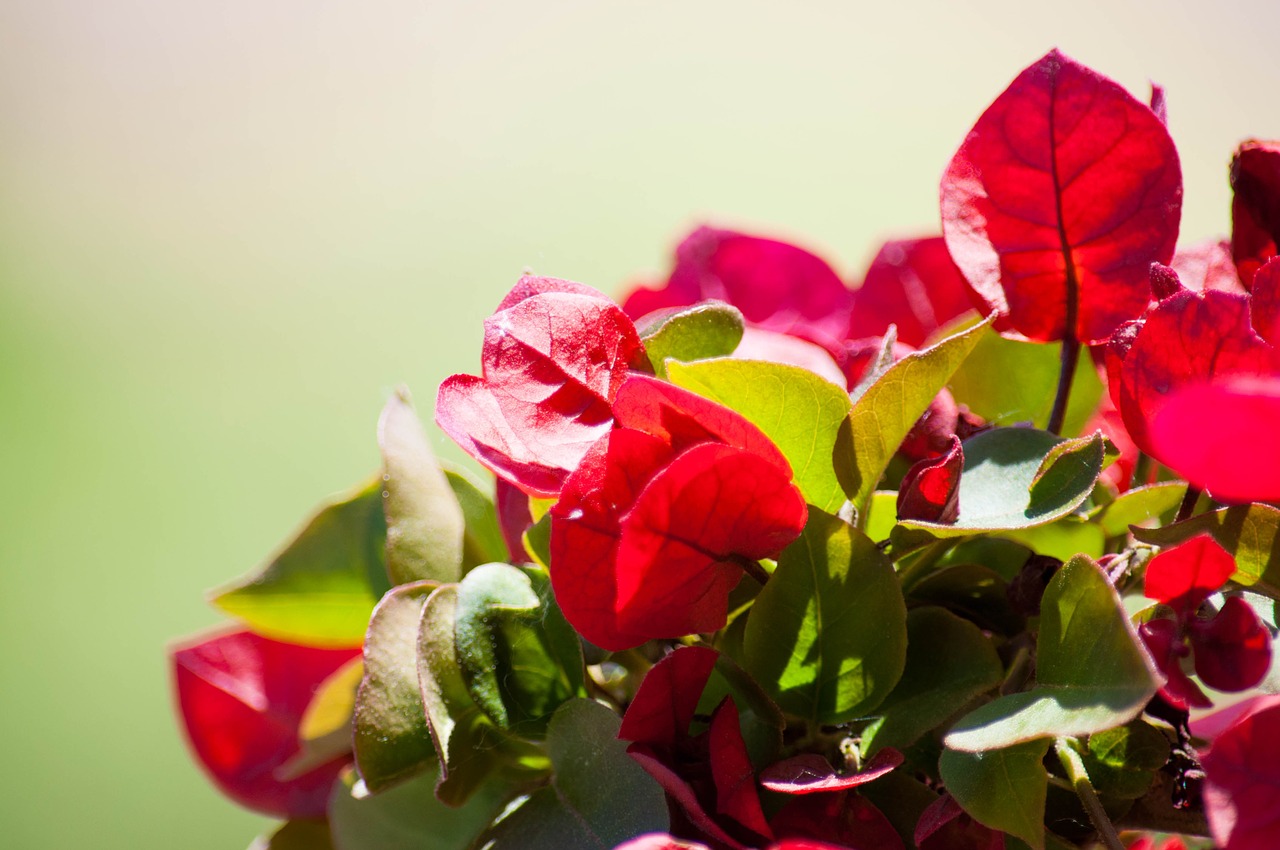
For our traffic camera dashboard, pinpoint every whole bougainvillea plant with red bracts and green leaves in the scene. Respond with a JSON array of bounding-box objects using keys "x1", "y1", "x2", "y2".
[{"x1": 172, "y1": 51, "x2": 1280, "y2": 850}]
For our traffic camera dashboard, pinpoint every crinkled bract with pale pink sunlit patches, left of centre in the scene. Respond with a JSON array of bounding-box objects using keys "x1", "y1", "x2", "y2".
[{"x1": 435, "y1": 278, "x2": 644, "y2": 497}]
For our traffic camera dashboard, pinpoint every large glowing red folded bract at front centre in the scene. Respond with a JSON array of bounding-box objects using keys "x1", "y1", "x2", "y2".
[{"x1": 550, "y1": 375, "x2": 808, "y2": 650}]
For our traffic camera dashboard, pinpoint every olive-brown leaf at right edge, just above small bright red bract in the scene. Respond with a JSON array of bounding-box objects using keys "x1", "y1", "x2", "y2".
[{"x1": 1132, "y1": 503, "x2": 1280, "y2": 598}]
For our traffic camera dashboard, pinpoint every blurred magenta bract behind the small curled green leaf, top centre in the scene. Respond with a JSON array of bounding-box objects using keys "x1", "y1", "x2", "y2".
[{"x1": 623, "y1": 227, "x2": 852, "y2": 347}]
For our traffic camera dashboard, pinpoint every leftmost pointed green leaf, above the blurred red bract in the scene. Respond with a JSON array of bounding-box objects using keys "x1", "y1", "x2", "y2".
[{"x1": 210, "y1": 481, "x2": 390, "y2": 646}]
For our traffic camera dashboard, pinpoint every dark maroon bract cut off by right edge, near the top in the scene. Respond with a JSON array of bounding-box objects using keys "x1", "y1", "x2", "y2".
[{"x1": 1231, "y1": 141, "x2": 1280, "y2": 288}]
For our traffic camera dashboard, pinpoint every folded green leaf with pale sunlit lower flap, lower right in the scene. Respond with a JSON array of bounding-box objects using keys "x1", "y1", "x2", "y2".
[{"x1": 946, "y1": 556, "x2": 1160, "y2": 751}]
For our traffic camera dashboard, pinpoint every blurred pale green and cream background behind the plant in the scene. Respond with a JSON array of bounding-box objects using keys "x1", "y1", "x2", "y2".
[{"x1": 0, "y1": 0, "x2": 1280, "y2": 850}]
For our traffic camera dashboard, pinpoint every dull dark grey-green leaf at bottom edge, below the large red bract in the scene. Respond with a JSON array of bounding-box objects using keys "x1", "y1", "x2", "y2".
[{"x1": 477, "y1": 699, "x2": 671, "y2": 850}]
